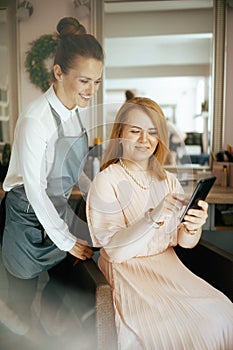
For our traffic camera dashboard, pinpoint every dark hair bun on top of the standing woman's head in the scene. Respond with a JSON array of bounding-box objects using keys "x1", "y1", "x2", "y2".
[{"x1": 57, "y1": 17, "x2": 87, "y2": 36}]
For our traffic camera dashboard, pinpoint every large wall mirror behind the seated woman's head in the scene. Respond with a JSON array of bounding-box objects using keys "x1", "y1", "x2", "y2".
[{"x1": 95, "y1": 0, "x2": 224, "y2": 169}]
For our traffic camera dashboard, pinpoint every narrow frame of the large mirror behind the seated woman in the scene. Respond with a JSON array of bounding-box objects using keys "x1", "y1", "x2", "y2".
[{"x1": 91, "y1": 0, "x2": 226, "y2": 170}]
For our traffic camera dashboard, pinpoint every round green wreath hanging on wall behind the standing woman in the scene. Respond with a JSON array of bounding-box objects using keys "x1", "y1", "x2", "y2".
[{"x1": 25, "y1": 34, "x2": 57, "y2": 92}]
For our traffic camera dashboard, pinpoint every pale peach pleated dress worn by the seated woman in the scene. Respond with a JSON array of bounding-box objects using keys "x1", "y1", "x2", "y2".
[{"x1": 87, "y1": 164, "x2": 233, "y2": 350}]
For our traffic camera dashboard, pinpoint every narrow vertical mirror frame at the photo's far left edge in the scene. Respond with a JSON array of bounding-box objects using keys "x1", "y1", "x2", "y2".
[{"x1": 0, "y1": 0, "x2": 18, "y2": 144}]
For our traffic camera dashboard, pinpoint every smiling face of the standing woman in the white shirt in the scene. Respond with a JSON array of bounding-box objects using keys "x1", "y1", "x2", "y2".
[{"x1": 54, "y1": 56, "x2": 103, "y2": 109}]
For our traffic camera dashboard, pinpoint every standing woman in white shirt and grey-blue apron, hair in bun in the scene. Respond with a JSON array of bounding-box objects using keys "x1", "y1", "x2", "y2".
[{"x1": 2, "y1": 17, "x2": 103, "y2": 328}]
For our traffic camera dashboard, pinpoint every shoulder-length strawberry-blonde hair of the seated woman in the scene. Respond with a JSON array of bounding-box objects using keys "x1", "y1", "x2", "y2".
[{"x1": 101, "y1": 97, "x2": 169, "y2": 179}]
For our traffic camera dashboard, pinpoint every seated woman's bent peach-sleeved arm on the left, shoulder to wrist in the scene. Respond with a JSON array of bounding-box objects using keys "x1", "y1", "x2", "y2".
[{"x1": 87, "y1": 173, "x2": 159, "y2": 263}]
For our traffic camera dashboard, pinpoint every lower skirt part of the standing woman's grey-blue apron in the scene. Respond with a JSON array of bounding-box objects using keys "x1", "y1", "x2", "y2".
[{"x1": 2, "y1": 187, "x2": 67, "y2": 279}]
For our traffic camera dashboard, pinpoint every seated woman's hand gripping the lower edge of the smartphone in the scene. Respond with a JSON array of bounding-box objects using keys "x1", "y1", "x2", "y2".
[{"x1": 183, "y1": 200, "x2": 208, "y2": 231}]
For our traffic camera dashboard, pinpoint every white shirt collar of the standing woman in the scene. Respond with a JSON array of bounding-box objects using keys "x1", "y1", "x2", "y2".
[{"x1": 45, "y1": 85, "x2": 80, "y2": 120}]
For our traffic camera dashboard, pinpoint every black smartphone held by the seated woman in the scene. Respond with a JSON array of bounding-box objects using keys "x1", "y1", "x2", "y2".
[{"x1": 180, "y1": 176, "x2": 216, "y2": 222}]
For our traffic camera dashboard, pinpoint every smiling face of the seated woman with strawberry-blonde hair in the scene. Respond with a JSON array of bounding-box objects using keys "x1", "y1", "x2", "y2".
[{"x1": 121, "y1": 108, "x2": 159, "y2": 170}]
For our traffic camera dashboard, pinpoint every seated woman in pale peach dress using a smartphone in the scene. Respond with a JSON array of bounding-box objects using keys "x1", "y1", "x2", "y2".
[{"x1": 87, "y1": 97, "x2": 233, "y2": 350}]
